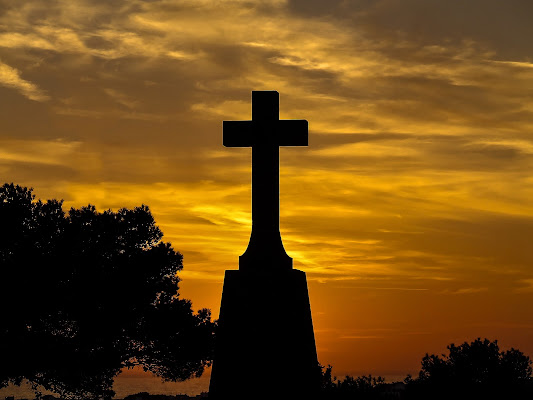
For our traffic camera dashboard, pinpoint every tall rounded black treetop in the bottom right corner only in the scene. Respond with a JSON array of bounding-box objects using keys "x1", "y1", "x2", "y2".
[{"x1": 406, "y1": 338, "x2": 532, "y2": 399}]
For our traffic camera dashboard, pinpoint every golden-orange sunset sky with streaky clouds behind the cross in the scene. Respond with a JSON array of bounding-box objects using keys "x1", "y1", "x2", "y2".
[{"x1": 0, "y1": 0, "x2": 533, "y2": 386}]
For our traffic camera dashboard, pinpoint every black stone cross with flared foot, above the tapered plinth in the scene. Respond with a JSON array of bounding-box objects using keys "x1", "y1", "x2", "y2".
[{"x1": 222, "y1": 91, "x2": 308, "y2": 271}]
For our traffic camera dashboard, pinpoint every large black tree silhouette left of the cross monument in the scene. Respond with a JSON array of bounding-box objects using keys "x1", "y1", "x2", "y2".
[{"x1": 0, "y1": 184, "x2": 214, "y2": 398}]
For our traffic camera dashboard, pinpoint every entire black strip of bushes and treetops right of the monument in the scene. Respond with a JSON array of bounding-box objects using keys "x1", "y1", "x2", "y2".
[{"x1": 321, "y1": 338, "x2": 533, "y2": 400}]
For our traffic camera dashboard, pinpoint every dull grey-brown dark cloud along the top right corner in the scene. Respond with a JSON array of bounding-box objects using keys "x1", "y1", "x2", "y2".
[{"x1": 289, "y1": 0, "x2": 533, "y2": 60}]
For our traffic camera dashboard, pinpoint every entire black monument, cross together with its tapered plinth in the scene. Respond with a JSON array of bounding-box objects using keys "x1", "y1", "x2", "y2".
[{"x1": 209, "y1": 91, "x2": 320, "y2": 400}]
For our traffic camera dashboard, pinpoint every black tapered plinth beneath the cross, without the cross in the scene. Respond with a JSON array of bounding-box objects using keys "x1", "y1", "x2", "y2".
[{"x1": 209, "y1": 269, "x2": 320, "y2": 400}]
